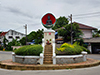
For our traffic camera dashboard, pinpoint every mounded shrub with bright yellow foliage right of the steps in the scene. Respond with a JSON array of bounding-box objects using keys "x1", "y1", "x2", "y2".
[{"x1": 56, "y1": 43, "x2": 83, "y2": 55}]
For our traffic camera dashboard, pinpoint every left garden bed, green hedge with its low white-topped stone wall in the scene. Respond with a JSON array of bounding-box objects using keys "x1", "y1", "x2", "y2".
[{"x1": 12, "y1": 45, "x2": 43, "y2": 64}]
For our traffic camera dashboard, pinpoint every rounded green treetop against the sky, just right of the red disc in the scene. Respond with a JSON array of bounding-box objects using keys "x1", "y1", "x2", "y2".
[{"x1": 52, "y1": 16, "x2": 69, "y2": 30}]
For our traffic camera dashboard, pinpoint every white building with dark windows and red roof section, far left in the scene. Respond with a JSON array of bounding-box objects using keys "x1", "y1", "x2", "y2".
[{"x1": 0, "y1": 29, "x2": 25, "y2": 43}]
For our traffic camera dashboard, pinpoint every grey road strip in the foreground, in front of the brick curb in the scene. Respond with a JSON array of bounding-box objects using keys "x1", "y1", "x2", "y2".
[{"x1": 0, "y1": 66, "x2": 100, "y2": 75}]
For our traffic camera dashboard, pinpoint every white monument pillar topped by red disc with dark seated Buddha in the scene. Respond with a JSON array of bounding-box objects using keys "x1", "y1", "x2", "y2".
[{"x1": 41, "y1": 13, "x2": 56, "y2": 64}]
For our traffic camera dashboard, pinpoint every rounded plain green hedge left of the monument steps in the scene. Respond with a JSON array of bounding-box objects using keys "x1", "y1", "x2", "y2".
[{"x1": 15, "y1": 45, "x2": 43, "y2": 56}]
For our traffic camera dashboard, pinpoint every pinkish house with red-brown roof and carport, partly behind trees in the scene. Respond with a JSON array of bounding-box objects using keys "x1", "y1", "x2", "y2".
[{"x1": 56, "y1": 22, "x2": 100, "y2": 54}]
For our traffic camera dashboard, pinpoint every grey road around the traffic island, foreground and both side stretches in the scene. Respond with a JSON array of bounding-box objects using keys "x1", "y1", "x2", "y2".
[{"x1": 0, "y1": 52, "x2": 100, "y2": 75}]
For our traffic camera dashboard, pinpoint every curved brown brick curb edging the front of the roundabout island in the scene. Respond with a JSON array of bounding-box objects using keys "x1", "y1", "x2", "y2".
[{"x1": 0, "y1": 59, "x2": 100, "y2": 70}]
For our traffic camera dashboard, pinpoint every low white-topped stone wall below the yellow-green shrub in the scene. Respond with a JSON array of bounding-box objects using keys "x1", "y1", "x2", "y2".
[{"x1": 56, "y1": 55, "x2": 83, "y2": 64}]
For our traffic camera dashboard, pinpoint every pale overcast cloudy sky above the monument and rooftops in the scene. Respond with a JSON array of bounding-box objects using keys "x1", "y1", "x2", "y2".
[{"x1": 0, "y1": 0, "x2": 100, "y2": 34}]
